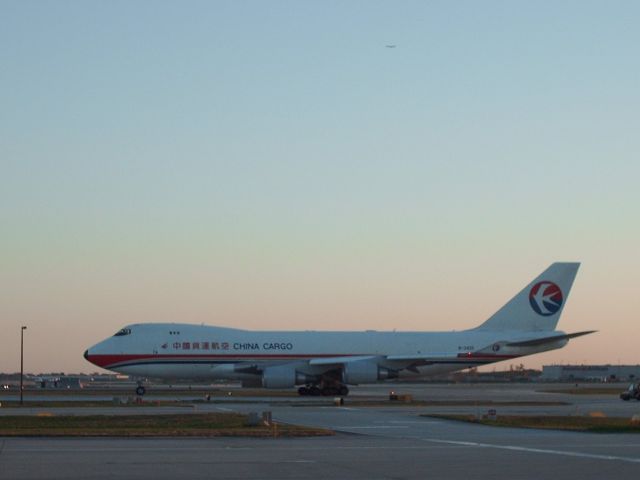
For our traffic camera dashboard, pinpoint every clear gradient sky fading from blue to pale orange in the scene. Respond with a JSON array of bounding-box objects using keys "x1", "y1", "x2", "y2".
[{"x1": 0, "y1": 0, "x2": 640, "y2": 372}]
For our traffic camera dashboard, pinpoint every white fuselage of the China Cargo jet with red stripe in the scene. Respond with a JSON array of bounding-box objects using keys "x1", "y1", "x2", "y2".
[{"x1": 86, "y1": 324, "x2": 567, "y2": 380}]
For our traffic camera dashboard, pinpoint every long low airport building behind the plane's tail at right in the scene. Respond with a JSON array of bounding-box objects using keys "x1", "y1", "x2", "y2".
[{"x1": 540, "y1": 365, "x2": 640, "y2": 382}]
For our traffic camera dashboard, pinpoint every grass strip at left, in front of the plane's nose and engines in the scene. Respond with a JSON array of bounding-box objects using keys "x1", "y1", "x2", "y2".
[{"x1": 0, "y1": 413, "x2": 333, "y2": 437}]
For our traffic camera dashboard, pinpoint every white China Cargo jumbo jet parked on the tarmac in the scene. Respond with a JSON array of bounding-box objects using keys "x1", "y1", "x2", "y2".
[{"x1": 84, "y1": 263, "x2": 595, "y2": 396}]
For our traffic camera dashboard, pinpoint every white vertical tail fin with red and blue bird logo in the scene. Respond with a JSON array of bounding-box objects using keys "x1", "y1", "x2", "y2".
[{"x1": 477, "y1": 263, "x2": 580, "y2": 331}]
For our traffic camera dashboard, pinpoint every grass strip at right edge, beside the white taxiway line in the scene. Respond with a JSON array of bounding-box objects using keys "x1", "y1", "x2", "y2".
[{"x1": 421, "y1": 414, "x2": 640, "y2": 433}]
